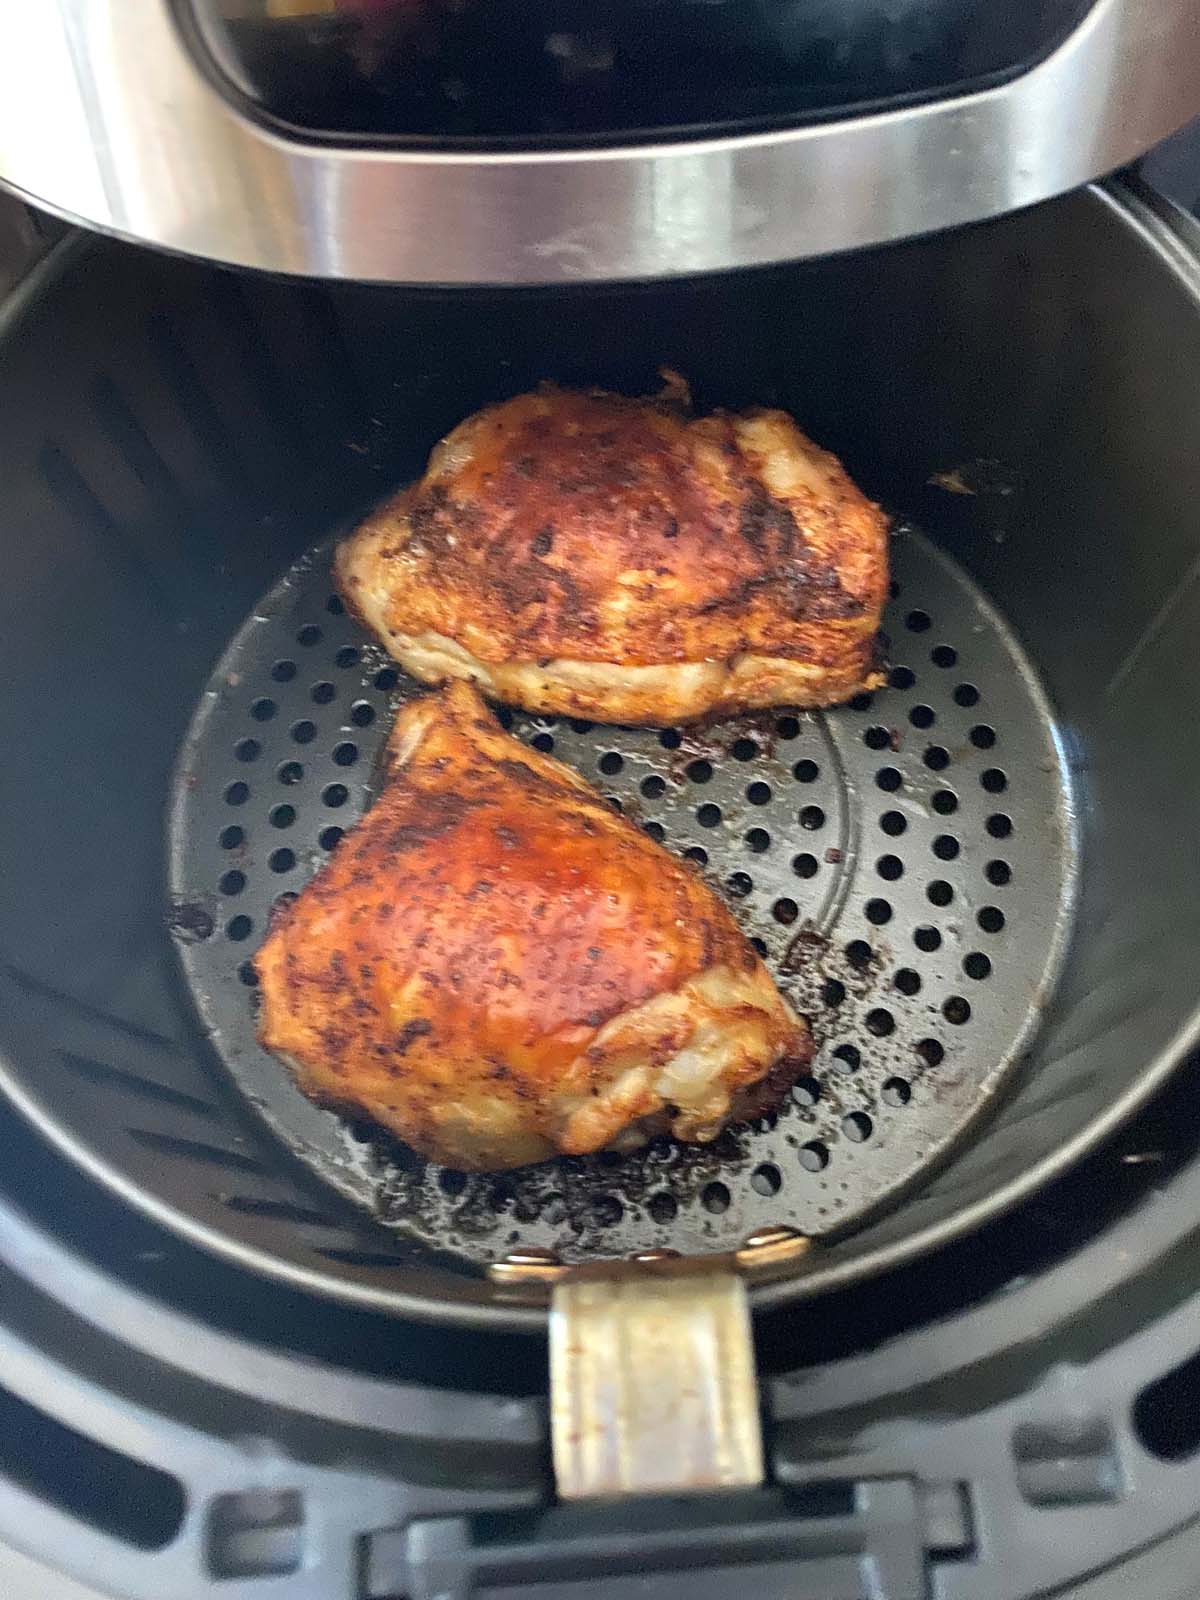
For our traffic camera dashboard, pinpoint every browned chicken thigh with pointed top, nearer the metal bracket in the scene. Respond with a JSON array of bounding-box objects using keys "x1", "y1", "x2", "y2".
[{"x1": 256, "y1": 682, "x2": 813, "y2": 1170}]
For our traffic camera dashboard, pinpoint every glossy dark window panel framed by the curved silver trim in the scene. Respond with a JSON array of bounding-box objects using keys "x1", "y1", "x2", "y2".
[{"x1": 184, "y1": 0, "x2": 1088, "y2": 144}]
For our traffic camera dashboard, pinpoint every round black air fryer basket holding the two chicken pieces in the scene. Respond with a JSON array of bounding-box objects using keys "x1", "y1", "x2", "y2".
[{"x1": 0, "y1": 178, "x2": 1200, "y2": 1350}]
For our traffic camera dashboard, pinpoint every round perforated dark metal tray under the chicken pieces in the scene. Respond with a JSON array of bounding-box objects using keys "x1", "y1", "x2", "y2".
[{"x1": 171, "y1": 528, "x2": 1075, "y2": 1264}]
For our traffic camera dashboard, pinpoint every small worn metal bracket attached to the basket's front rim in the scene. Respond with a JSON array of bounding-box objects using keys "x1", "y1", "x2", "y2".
[{"x1": 550, "y1": 1266, "x2": 763, "y2": 1499}]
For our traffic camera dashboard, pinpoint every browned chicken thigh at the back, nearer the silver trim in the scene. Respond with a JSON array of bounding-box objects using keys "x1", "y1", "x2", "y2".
[{"x1": 336, "y1": 379, "x2": 888, "y2": 725}]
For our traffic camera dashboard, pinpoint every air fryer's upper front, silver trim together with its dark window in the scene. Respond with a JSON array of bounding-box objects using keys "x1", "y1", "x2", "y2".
[{"x1": 0, "y1": 0, "x2": 1200, "y2": 283}]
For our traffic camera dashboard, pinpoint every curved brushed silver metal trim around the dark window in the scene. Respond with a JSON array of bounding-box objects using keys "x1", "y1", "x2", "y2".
[{"x1": 0, "y1": 0, "x2": 1200, "y2": 285}]
